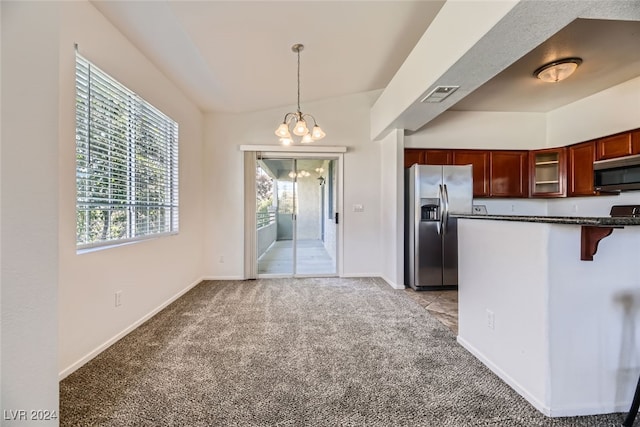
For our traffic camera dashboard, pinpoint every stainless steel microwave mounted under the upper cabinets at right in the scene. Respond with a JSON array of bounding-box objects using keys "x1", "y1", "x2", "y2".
[{"x1": 593, "y1": 154, "x2": 640, "y2": 191}]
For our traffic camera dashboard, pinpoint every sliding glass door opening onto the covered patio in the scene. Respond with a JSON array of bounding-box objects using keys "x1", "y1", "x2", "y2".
[{"x1": 256, "y1": 156, "x2": 337, "y2": 277}]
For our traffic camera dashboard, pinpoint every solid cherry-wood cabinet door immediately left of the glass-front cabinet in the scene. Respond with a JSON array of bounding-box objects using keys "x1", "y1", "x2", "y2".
[{"x1": 489, "y1": 150, "x2": 529, "y2": 197}]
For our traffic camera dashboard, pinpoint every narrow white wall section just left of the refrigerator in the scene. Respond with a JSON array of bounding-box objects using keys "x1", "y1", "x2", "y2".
[{"x1": 378, "y1": 129, "x2": 404, "y2": 289}]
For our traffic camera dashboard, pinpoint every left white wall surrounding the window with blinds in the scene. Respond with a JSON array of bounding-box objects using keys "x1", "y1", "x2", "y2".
[{"x1": 56, "y1": 2, "x2": 204, "y2": 376}]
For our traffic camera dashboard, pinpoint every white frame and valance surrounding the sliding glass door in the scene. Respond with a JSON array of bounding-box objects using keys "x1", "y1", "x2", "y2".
[{"x1": 240, "y1": 145, "x2": 347, "y2": 279}]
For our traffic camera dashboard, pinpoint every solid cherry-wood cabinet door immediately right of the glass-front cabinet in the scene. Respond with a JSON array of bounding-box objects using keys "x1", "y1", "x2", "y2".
[{"x1": 567, "y1": 141, "x2": 596, "y2": 196}]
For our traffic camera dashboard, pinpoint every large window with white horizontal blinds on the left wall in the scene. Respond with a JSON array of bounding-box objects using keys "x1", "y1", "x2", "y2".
[{"x1": 76, "y1": 54, "x2": 178, "y2": 249}]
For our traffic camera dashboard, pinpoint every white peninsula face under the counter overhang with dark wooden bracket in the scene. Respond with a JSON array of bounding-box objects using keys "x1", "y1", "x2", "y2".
[{"x1": 547, "y1": 226, "x2": 640, "y2": 415}]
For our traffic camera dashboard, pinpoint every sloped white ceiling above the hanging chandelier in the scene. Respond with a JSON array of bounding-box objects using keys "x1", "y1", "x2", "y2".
[{"x1": 92, "y1": 0, "x2": 444, "y2": 113}]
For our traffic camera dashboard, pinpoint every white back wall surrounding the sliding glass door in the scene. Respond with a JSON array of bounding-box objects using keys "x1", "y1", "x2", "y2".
[{"x1": 203, "y1": 91, "x2": 381, "y2": 278}]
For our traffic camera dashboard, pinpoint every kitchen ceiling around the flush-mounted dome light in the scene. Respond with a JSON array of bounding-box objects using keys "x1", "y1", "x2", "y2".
[{"x1": 451, "y1": 19, "x2": 640, "y2": 113}]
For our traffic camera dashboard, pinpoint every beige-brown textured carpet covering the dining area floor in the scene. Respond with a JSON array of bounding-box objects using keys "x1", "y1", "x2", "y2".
[{"x1": 60, "y1": 278, "x2": 636, "y2": 427}]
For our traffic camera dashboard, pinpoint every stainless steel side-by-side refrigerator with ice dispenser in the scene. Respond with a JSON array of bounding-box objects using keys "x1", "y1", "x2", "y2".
[{"x1": 405, "y1": 164, "x2": 473, "y2": 290}]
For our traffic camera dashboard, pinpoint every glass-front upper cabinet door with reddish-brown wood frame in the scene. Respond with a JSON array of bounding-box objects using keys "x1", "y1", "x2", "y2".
[{"x1": 529, "y1": 148, "x2": 567, "y2": 197}]
